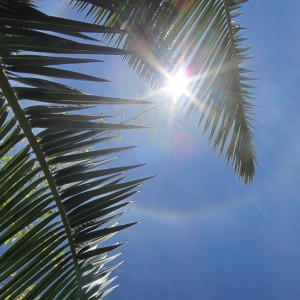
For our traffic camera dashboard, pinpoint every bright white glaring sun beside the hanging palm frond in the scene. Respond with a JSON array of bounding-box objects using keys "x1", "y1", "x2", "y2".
[{"x1": 166, "y1": 68, "x2": 189, "y2": 100}]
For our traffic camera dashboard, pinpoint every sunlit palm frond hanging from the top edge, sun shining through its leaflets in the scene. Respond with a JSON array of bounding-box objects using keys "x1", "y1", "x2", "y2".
[{"x1": 71, "y1": 0, "x2": 256, "y2": 183}]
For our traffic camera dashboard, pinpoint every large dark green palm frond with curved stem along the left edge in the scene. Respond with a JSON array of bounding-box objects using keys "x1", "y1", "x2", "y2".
[{"x1": 0, "y1": 0, "x2": 148, "y2": 299}]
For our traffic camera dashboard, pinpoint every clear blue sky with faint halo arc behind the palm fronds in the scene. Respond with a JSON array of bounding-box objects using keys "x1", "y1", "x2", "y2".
[{"x1": 5, "y1": 0, "x2": 300, "y2": 300}]
